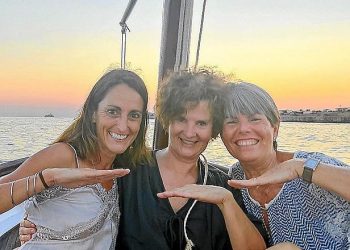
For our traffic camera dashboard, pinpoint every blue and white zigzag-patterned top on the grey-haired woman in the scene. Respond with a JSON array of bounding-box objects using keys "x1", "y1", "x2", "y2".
[{"x1": 229, "y1": 151, "x2": 350, "y2": 250}]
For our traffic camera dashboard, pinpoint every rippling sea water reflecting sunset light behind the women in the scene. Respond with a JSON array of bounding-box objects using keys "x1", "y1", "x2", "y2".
[{"x1": 0, "y1": 117, "x2": 350, "y2": 166}]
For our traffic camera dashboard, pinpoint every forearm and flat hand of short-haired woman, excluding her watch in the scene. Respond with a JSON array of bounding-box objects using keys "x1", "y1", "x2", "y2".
[{"x1": 228, "y1": 159, "x2": 350, "y2": 201}]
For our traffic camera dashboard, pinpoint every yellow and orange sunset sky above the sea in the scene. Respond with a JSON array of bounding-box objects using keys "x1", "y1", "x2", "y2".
[{"x1": 0, "y1": 0, "x2": 350, "y2": 117}]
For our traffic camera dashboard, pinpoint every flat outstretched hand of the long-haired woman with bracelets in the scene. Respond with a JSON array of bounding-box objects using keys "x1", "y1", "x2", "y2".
[{"x1": 43, "y1": 168, "x2": 130, "y2": 188}]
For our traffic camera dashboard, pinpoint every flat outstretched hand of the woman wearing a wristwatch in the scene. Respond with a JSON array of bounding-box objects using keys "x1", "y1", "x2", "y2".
[{"x1": 228, "y1": 159, "x2": 304, "y2": 188}]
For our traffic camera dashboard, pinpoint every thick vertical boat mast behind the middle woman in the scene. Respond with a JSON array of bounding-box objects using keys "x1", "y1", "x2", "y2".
[{"x1": 153, "y1": 0, "x2": 193, "y2": 149}]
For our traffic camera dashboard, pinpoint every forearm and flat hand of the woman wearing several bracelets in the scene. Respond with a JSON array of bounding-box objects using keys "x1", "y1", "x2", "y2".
[{"x1": 0, "y1": 168, "x2": 130, "y2": 213}]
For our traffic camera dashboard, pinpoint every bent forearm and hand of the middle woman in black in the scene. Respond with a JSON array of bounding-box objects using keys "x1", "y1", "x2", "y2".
[{"x1": 158, "y1": 184, "x2": 266, "y2": 249}]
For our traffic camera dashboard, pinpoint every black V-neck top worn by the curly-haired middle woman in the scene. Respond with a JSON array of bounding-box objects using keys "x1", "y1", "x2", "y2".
[{"x1": 116, "y1": 155, "x2": 266, "y2": 250}]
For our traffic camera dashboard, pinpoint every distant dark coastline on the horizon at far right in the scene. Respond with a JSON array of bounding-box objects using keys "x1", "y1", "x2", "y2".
[{"x1": 280, "y1": 108, "x2": 350, "y2": 123}]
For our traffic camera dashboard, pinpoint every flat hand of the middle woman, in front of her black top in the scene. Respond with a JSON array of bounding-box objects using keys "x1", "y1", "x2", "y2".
[{"x1": 157, "y1": 184, "x2": 233, "y2": 206}]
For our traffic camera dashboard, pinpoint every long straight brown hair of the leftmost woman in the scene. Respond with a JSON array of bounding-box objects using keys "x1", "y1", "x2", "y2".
[{"x1": 55, "y1": 69, "x2": 150, "y2": 167}]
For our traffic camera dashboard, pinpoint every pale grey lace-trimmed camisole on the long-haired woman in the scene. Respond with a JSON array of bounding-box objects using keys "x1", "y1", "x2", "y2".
[{"x1": 20, "y1": 144, "x2": 120, "y2": 250}]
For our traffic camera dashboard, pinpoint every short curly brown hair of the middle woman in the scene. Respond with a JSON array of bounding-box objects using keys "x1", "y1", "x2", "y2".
[{"x1": 155, "y1": 70, "x2": 224, "y2": 138}]
